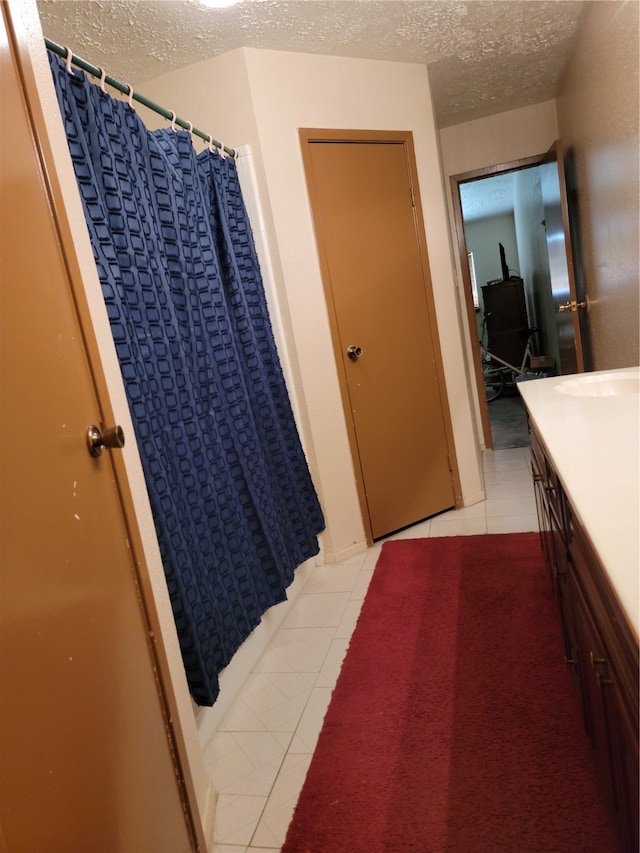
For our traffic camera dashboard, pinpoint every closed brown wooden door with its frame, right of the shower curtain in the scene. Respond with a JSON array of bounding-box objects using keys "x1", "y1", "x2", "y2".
[{"x1": 301, "y1": 131, "x2": 455, "y2": 539}]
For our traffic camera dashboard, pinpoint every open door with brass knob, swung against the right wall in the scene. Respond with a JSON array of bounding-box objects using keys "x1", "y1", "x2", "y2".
[{"x1": 539, "y1": 141, "x2": 586, "y2": 374}]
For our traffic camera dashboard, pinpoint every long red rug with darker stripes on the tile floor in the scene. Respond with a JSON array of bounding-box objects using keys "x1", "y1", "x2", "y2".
[{"x1": 282, "y1": 533, "x2": 616, "y2": 853}]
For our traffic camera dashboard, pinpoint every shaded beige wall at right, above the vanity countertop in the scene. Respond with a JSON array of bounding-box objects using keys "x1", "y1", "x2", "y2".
[{"x1": 557, "y1": 0, "x2": 640, "y2": 370}]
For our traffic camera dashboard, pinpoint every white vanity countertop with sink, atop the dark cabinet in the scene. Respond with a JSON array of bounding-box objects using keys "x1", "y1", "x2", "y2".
[{"x1": 518, "y1": 367, "x2": 640, "y2": 635}]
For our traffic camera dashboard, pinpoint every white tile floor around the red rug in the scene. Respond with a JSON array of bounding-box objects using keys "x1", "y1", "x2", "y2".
[{"x1": 204, "y1": 447, "x2": 538, "y2": 853}]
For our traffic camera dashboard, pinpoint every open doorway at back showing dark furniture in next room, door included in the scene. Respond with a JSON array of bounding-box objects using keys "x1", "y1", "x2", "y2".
[{"x1": 451, "y1": 143, "x2": 586, "y2": 448}]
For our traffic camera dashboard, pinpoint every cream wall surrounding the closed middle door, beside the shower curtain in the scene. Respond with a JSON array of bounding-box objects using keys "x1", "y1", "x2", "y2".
[{"x1": 144, "y1": 49, "x2": 482, "y2": 561}]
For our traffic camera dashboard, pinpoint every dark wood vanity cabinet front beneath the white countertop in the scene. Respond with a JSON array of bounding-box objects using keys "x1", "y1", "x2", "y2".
[{"x1": 530, "y1": 424, "x2": 639, "y2": 853}]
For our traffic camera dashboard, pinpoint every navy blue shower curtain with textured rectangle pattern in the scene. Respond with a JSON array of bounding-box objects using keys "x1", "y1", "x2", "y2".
[{"x1": 49, "y1": 55, "x2": 324, "y2": 705}]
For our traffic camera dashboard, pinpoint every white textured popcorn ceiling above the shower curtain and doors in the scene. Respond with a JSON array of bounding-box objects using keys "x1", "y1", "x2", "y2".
[{"x1": 38, "y1": 0, "x2": 585, "y2": 127}]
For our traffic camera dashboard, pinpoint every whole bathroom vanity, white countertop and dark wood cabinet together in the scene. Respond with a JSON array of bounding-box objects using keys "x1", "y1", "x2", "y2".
[{"x1": 518, "y1": 368, "x2": 640, "y2": 853}]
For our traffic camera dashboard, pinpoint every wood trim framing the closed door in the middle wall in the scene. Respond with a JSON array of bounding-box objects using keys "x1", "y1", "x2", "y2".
[{"x1": 299, "y1": 128, "x2": 462, "y2": 545}]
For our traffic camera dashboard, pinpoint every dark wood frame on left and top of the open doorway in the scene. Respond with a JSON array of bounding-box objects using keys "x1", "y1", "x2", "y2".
[{"x1": 449, "y1": 152, "x2": 549, "y2": 450}]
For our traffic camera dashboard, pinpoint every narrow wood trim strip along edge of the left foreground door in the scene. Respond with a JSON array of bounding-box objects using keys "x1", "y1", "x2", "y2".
[{"x1": 2, "y1": 3, "x2": 207, "y2": 851}]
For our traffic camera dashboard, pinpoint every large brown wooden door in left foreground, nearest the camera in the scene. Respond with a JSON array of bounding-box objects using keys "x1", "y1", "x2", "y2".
[{"x1": 0, "y1": 3, "x2": 202, "y2": 853}]
